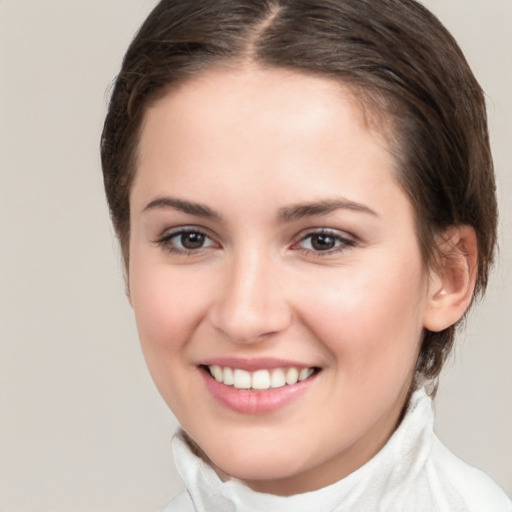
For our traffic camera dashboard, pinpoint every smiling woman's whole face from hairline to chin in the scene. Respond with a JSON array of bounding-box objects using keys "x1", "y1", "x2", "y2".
[{"x1": 129, "y1": 68, "x2": 428, "y2": 494}]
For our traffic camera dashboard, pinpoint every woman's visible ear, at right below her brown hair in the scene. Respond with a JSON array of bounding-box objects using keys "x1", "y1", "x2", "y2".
[{"x1": 423, "y1": 225, "x2": 478, "y2": 332}]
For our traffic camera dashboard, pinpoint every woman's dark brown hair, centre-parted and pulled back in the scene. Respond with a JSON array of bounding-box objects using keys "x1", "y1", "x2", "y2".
[{"x1": 101, "y1": 0, "x2": 497, "y2": 378}]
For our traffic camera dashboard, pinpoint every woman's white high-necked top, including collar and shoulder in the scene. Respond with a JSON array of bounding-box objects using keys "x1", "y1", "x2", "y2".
[{"x1": 160, "y1": 390, "x2": 512, "y2": 512}]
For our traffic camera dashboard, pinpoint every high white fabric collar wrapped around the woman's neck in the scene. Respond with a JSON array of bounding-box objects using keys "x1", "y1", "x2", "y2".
[{"x1": 172, "y1": 390, "x2": 434, "y2": 512}]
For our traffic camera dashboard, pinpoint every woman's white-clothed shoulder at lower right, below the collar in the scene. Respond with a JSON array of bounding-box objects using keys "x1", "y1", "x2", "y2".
[{"x1": 427, "y1": 437, "x2": 512, "y2": 512}]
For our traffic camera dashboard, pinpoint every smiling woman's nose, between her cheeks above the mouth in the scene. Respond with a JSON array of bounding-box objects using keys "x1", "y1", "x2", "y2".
[{"x1": 209, "y1": 251, "x2": 292, "y2": 344}]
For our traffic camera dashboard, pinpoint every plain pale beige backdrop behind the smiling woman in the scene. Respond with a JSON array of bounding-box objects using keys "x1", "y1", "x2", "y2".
[{"x1": 0, "y1": 0, "x2": 512, "y2": 512}]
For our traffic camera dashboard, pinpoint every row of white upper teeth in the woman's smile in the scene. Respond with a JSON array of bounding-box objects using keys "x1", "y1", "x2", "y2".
[{"x1": 208, "y1": 365, "x2": 315, "y2": 390}]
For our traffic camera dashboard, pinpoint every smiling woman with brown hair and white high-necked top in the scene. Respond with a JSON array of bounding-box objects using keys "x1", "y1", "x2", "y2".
[{"x1": 102, "y1": 0, "x2": 511, "y2": 511}]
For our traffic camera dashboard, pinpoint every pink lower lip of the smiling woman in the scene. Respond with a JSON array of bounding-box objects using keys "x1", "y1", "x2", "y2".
[{"x1": 200, "y1": 369, "x2": 316, "y2": 414}]
